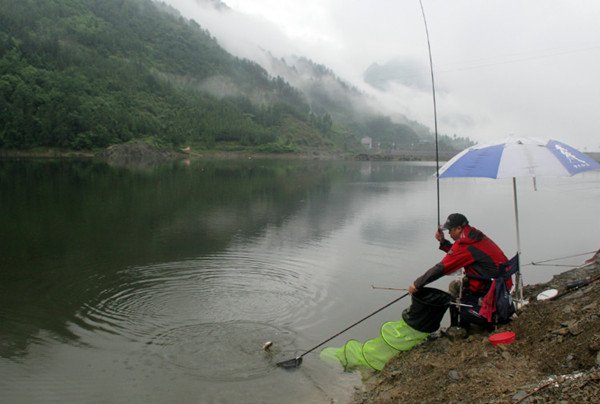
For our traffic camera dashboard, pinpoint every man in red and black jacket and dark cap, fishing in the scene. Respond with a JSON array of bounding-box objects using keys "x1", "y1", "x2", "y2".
[{"x1": 408, "y1": 213, "x2": 512, "y2": 328}]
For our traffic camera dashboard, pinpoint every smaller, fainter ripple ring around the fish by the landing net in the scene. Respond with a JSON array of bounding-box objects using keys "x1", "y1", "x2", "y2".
[{"x1": 147, "y1": 321, "x2": 295, "y2": 381}]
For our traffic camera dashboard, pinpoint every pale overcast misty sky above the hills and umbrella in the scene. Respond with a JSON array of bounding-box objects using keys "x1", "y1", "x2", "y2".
[{"x1": 166, "y1": 0, "x2": 600, "y2": 151}]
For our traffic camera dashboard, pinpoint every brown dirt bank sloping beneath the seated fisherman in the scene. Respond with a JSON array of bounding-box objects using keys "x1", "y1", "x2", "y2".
[{"x1": 352, "y1": 257, "x2": 600, "y2": 404}]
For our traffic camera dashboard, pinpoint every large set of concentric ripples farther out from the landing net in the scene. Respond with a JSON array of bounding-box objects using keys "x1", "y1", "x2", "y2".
[{"x1": 75, "y1": 251, "x2": 325, "y2": 340}]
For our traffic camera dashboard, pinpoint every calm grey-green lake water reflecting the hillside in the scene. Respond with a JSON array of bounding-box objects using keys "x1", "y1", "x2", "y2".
[{"x1": 0, "y1": 160, "x2": 600, "y2": 403}]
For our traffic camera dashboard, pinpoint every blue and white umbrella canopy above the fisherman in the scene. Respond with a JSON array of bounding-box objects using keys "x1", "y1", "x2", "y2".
[{"x1": 439, "y1": 136, "x2": 600, "y2": 178}]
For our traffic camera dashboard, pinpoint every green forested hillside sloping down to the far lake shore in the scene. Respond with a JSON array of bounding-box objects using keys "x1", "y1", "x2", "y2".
[{"x1": 0, "y1": 0, "x2": 474, "y2": 151}]
